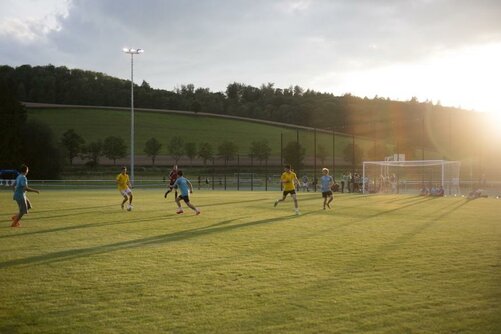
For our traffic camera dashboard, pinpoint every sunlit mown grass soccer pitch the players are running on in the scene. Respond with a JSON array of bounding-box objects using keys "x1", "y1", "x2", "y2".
[{"x1": 0, "y1": 189, "x2": 501, "y2": 333}]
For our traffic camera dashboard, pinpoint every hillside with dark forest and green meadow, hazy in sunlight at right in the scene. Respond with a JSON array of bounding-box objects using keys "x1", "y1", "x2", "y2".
[{"x1": 4, "y1": 65, "x2": 501, "y2": 178}]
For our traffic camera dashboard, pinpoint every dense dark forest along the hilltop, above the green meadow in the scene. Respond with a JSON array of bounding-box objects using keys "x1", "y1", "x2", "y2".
[{"x1": 0, "y1": 65, "x2": 479, "y2": 162}]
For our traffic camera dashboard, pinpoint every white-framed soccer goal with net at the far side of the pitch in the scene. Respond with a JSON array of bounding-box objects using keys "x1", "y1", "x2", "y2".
[{"x1": 362, "y1": 160, "x2": 461, "y2": 196}]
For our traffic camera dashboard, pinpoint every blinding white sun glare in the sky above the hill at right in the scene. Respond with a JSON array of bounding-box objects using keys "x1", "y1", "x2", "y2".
[{"x1": 314, "y1": 44, "x2": 501, "y2": 124}]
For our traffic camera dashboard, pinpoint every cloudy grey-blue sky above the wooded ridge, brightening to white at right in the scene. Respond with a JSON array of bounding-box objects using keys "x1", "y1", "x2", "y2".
[{"x1": 0, "y1": 0, "x2": 501, "y2": 118}]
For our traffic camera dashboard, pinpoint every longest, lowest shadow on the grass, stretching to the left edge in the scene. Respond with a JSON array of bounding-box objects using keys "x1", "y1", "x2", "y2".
[{"x1": 0, "y1": 213, "x2": 308, "y2": 269}]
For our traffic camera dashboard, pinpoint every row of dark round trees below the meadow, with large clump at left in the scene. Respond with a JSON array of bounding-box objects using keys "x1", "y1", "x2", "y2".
[{"x1": 0, "y1": 74, "x2": 348, "y2": 179}]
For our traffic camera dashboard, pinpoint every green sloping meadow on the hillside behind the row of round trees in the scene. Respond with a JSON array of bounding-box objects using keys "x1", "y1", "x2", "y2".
[{"x1": 28, "y1": 108, "x2": 360, "y2": 156}]
